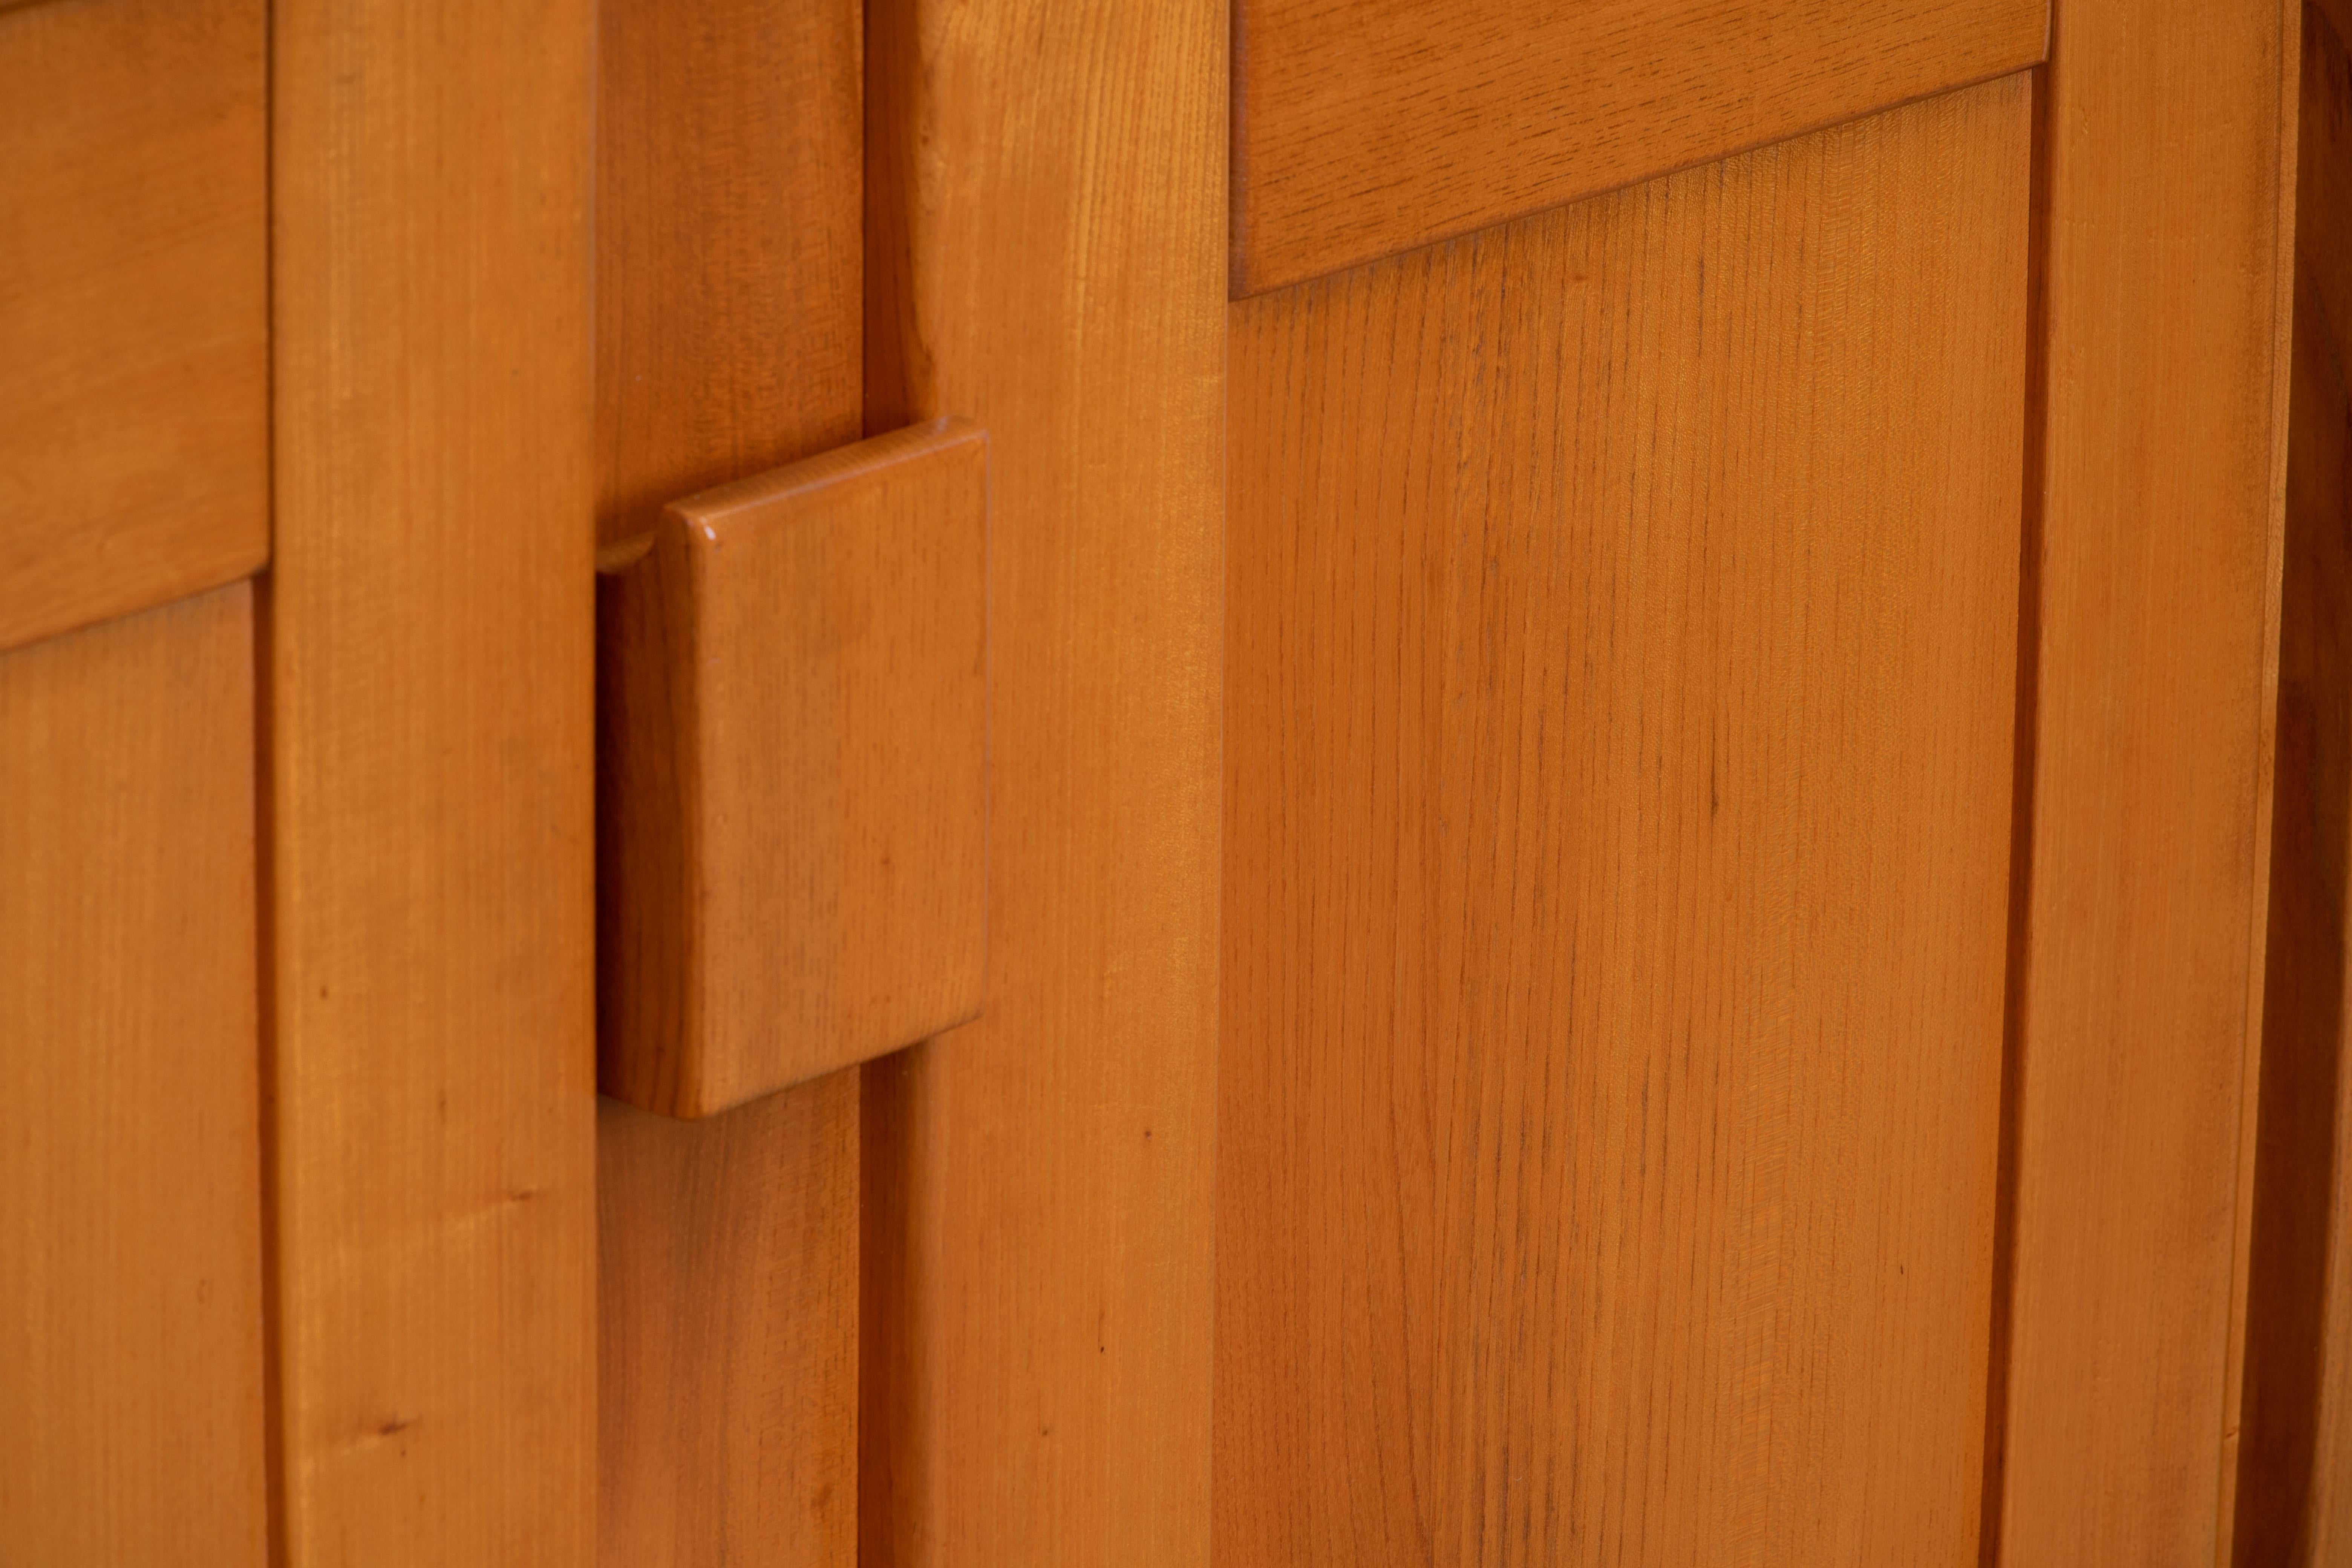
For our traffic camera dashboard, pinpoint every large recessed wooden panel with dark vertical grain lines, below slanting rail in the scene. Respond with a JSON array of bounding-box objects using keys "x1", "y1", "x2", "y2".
[{"x1": 1214, "y1": 75, "x2": 2030, "y2": 1568}]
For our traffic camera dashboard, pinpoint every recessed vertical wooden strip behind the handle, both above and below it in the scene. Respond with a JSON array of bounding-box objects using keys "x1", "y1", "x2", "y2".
[{"x1": 595, "y1": 0, "x2": 865, "y2": 1568}]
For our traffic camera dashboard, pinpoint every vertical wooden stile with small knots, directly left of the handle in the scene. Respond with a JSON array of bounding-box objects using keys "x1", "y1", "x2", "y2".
[{"x1": 266, "y1": 0, "x2": 597, "y2": 1568}]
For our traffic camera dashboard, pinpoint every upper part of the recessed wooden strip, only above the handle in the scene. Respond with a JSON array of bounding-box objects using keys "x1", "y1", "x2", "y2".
[{"x1": 595, "y1": 0, "x2": 865, "y2": 541}]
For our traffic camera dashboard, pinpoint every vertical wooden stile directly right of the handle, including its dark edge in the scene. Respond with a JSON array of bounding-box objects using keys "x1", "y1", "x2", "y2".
[{"x1": 861, "y1": 0, "x2": 1228, "y2": 1568}]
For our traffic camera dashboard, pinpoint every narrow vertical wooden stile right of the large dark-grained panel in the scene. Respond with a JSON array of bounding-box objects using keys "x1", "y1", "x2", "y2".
[{"x1": 1997, "y1": 0, "x2": 2295, "y2": 1568}]
